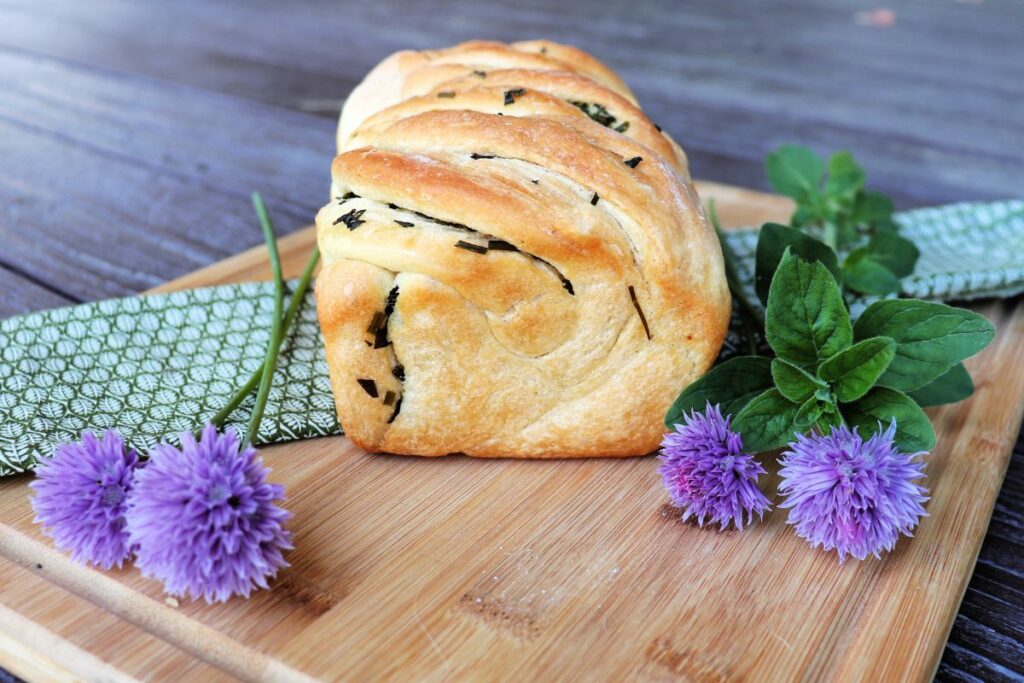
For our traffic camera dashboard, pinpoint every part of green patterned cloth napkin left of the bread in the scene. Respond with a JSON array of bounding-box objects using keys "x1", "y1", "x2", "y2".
[{"x1": 0, "y1": 283, "x2": 341, "y2": 476}]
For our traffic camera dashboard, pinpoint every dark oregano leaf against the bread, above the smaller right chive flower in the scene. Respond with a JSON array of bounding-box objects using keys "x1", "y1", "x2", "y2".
[{"x1": 665, "y1": 355, "x2": 772, "y2": 429}]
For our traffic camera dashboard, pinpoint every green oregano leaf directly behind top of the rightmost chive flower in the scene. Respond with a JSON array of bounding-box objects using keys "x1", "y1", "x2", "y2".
[{"x1": 840, "y1": 387, "x2": 935, "y2": 453}]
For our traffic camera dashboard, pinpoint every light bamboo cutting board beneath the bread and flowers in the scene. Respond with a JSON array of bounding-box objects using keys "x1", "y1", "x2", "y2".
[{"x1": 0, "y1": 183, "x2": 1024, "y2": 681}]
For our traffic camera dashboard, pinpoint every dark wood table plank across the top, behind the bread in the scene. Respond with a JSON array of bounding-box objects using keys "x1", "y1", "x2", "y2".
[{"x1": 0, "y1": 0, "x2": 1024, "y2": 206}]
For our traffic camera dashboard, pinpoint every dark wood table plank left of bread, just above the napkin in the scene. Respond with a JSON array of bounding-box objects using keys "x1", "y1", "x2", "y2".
[{"x1": 0, "y1": 44, "x2": 333, "y2": 313}]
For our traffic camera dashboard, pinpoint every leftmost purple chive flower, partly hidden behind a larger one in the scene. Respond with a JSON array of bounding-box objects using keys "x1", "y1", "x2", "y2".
[{"x1": 29, "y1": 429, "x2": 139, "y2": 569}]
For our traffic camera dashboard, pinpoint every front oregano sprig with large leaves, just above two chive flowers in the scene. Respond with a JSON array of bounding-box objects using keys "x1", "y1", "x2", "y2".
[{"x1": 666, "y1": 247, "x2": 995, "y2": 453}]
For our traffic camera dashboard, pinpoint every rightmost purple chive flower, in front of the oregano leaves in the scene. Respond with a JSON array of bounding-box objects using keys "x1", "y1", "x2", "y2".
[{"x1": 779, "y1": 420, "x2": 928, "y2": 562}]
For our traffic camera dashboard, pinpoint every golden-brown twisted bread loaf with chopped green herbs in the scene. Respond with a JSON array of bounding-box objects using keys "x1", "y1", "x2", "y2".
[{"x1": 316, "y1": 36, "x2": 730, "y2": 458}]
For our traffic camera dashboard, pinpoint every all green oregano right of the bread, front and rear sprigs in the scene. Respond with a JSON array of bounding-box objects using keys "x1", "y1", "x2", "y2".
[{"x1": 666, "y1": 146, "x2": 995, "y2": 453}]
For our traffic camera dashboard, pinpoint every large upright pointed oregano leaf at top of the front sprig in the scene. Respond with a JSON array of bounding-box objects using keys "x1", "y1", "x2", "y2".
[{"x1": 765, "y1": 251, "x2": 853, "y2": 368}]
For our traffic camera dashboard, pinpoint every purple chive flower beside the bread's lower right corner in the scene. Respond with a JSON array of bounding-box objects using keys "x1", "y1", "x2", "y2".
[{"x1": 657, "y1": 403, "x2": 771, "y2": 529}]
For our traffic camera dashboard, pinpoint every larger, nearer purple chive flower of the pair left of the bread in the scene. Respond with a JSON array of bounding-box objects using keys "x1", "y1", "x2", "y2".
[{"x1": 128, "y1": 425, "x2": 292, "y2": 602}]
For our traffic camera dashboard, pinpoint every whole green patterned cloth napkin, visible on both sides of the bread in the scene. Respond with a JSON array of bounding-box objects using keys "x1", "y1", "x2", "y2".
[{"x1": 0, "y1": 201, "x2": 1024, "y2": 476}]
